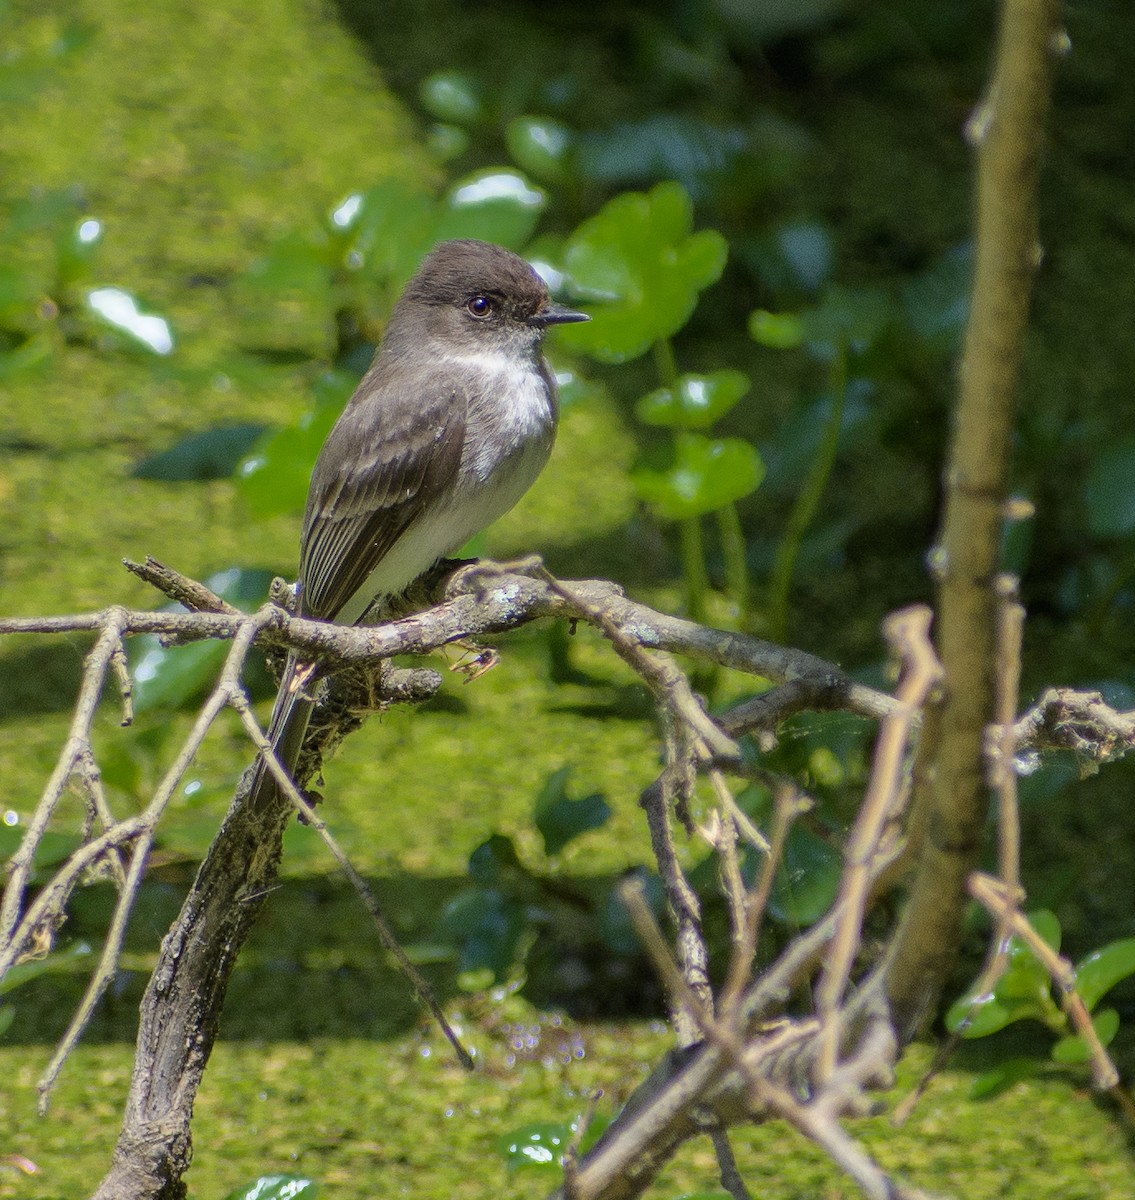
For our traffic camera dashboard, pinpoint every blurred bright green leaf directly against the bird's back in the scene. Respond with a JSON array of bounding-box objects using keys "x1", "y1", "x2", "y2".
[{"x1": 236, "y1": 371, "x2": 359, "y2": 517}]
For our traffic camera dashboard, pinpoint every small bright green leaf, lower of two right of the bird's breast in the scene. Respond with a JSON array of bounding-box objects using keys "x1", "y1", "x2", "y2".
[{"x1": 631, "y1": 433, "x2": 764, "y2": 521}]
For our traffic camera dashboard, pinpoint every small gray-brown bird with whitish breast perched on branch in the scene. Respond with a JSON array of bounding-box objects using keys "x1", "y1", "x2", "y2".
[{"x1": 250, "y1": 240, "x2": 588, "y2": 803}]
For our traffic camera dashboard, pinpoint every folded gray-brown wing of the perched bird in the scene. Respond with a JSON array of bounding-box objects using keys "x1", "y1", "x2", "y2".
[{"x1": 300, "y1": 371, "x2": 467, "y2": 620}]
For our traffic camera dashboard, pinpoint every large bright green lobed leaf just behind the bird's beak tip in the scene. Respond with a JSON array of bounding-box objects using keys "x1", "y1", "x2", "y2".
[{"x1": 560, "y1": 182, "x2": 726, "y2": 362}]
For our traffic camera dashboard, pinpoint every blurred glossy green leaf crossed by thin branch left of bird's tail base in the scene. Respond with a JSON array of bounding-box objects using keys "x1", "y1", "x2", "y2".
[{"x1": 130, "y1": 566, "x2": 274, "y2": 713}]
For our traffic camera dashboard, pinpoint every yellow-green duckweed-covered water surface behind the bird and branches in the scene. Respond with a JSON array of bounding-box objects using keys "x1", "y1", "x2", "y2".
[{"x1": 0, "y1": 0, "x2": 1135, "y2": 1200}]
